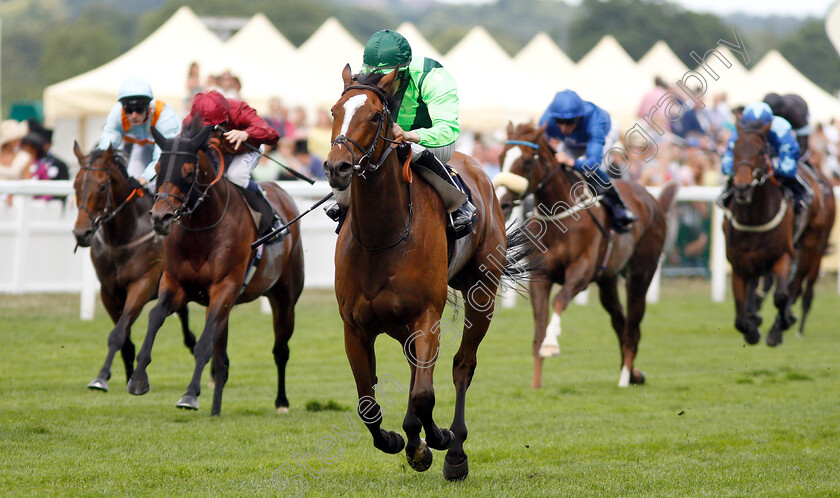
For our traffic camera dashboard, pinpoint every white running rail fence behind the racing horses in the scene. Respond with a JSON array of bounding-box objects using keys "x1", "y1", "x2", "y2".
[{"x1": 0, "y1": 180, "x2": 840, "y2": 318}]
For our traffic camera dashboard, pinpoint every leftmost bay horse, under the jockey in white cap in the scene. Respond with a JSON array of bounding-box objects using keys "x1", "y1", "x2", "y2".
[{"x1": 73, "y1": 142, "x2": 195, "y2": 391}]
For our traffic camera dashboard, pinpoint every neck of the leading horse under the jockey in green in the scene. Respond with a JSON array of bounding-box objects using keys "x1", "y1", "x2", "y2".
[{"x1": 350, "y1": 155, "x2": 410, "y2": 248}]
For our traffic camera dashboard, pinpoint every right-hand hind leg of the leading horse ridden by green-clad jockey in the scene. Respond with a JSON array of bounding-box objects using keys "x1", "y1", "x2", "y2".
[{"x1": 443, "y1": 293, "x2": 495, "y2": 481}]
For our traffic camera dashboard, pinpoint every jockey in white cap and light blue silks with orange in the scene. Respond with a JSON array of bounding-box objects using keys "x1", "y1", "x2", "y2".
[{"x1": 96, "y1": 76, "x2": 181, "y2": 191}]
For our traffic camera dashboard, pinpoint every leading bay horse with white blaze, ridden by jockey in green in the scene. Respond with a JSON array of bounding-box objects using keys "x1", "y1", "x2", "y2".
[{"x1": 324, "y1": 64, "x2": 526, "y2": 480}]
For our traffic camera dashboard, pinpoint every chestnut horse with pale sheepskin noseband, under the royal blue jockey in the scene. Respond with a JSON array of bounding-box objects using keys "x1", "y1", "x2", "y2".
[{"x1": 494, "y1": 123, "x2": 678, "y2": 389}]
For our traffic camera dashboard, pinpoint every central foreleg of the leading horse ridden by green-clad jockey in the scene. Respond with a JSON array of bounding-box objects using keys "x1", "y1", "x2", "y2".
[{"x1": 403, "y1": 308, "x2": 452, "y2": 472}]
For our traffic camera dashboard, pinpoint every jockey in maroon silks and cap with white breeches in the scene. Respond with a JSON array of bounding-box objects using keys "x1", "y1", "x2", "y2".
[{"x1": 183, "y1": 90, "x2": 283, "y2": 240}]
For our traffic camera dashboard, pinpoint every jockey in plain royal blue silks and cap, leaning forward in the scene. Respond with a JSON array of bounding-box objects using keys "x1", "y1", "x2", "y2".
[{"x1": 540, "y1": 90, "x2": 637, "y2": 232}]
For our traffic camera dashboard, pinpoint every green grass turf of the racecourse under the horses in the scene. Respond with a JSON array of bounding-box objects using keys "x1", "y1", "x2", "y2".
[{"x1": 0, "y1": 279, "x2": 840, "y2": 497}]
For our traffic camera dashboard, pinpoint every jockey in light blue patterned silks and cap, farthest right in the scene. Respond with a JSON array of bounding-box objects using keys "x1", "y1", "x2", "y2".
[{"x1": 718, "y1": 102, "x2": 814, "y2": 213}]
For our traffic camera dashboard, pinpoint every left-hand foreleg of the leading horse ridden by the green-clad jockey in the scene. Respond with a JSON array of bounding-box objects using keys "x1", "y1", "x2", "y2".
[{"x1": 344, "y1": 323, "x2": 405, "y2": 454}]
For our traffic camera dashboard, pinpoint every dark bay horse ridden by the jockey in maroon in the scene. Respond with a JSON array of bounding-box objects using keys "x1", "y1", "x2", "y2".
[{"x1": 128, "y1": 120, "x2": 303, "y2": 415}]
